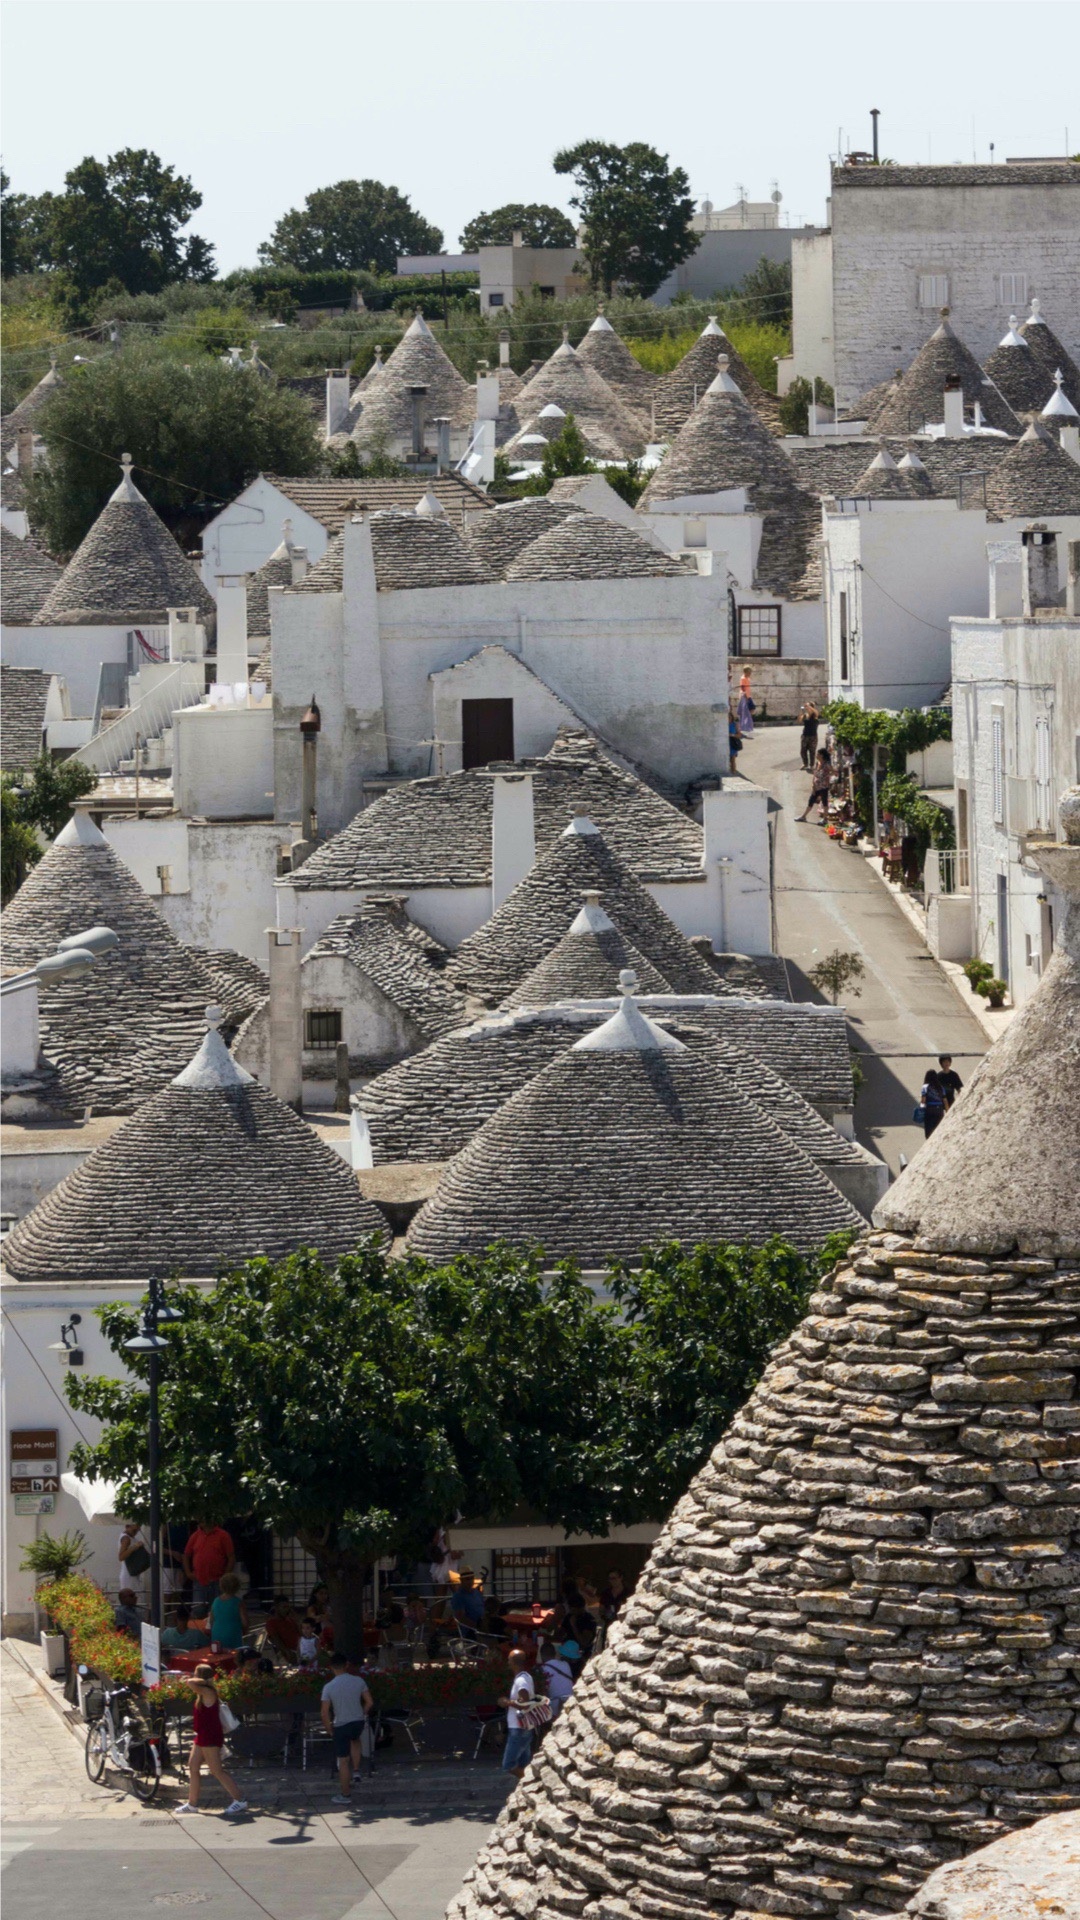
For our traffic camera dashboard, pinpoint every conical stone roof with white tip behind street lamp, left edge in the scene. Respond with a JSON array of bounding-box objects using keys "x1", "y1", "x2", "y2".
[{"x1": 0, "y1": 814, "x2": 209, "y2": 1114}]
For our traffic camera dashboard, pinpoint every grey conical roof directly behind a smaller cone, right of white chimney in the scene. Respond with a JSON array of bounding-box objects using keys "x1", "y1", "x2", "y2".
[{"x1": 448, "y1": 820, "x2": 717, "y2": 1006}]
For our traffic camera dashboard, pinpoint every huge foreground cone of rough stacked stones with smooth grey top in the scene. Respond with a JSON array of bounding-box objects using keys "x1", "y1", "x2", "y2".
[{"x1": 450, "y1": 806, "x2": 1080, "y2": 1920}]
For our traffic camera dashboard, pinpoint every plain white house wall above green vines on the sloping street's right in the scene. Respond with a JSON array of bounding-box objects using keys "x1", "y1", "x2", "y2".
[{"x1": 822, "y1": 499, "x2": 1080, "y2": 708}]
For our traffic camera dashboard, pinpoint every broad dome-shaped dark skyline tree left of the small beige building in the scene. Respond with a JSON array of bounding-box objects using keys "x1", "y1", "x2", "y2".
[{"x1": 259, "y1": 180, "x2": 442, "y2": 273}]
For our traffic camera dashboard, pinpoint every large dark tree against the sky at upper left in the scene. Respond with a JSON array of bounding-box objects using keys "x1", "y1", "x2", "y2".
[{"x1": 44, "y1": 148, "x2": 213, "y2": 305}]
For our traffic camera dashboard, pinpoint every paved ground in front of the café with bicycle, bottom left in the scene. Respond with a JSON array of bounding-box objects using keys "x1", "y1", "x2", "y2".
[{"x1": 0, "y1": 1647, "x2": 507, "y2": 1920}]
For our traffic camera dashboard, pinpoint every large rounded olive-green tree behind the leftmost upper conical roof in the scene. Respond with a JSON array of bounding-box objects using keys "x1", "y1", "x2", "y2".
[{"x1": 27, "y1": 342, "x2": 321, "y2": 553}]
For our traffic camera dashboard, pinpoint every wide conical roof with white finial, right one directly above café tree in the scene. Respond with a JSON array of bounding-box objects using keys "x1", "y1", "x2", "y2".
[{"x1": 407, "y1": 998, "x2": 859, "y2": 1267}]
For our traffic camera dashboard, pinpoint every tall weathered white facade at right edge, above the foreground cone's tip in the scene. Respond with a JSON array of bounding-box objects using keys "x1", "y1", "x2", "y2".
[{"x1": 953, "y1": 543, "x2": 1080, "y2": 1006}]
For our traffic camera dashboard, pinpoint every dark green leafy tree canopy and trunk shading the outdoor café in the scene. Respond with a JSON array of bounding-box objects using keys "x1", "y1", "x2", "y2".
[{"x1": 67, "y1": 1240, "x2": 845, "y2": 1651}]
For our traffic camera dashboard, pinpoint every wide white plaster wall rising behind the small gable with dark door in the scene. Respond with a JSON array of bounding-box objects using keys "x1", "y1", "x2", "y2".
[{"x1": 271, "y1": 515, "x2": 728, "y2": 837}]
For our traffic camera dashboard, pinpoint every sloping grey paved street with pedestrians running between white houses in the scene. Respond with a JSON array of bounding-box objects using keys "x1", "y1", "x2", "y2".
[{"x1": 738, "y1": 726, "x2": 988, "y2": 1173}]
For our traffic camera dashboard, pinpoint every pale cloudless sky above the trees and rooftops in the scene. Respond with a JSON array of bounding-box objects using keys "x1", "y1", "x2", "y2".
[{"x1": 2, "y1": 0, "x2": 1080, "y2": 273}]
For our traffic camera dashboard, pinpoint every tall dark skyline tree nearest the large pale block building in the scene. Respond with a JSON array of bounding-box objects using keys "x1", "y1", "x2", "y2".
[{"x1": 553, "y1": 140, "x2": 700, "y2": 300}]
